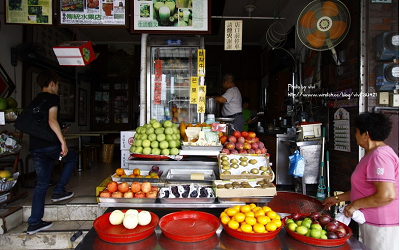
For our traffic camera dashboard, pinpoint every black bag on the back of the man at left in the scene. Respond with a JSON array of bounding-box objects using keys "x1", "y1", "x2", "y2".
[{"x1": 14, "y1": 99, "x2": 58, "y2": 142}]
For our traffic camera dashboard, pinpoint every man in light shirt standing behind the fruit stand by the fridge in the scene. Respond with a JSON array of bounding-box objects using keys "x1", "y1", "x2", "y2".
[{"x1": 215, "y1": 73, "x2": 244, "y2": 131}]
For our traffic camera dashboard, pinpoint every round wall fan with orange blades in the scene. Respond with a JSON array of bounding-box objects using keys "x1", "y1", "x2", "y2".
[{"x1": 296, "y1": 0, "x2": 350, "y2": 65}]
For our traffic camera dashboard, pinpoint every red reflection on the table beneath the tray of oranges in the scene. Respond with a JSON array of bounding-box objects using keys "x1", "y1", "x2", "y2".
[{"x1": 219, "y1": 230, "x2": 282, "y2": 250}]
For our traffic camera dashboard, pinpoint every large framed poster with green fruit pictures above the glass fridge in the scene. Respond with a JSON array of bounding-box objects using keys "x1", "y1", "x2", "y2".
[{"x1": 130, "y1": 0, "x2": 211, "y2": 34}]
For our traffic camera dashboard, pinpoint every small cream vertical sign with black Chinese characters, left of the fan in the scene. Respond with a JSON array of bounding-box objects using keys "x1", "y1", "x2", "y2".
[{"x1": 224, "y1": 20, "x2": 243, "y2": 50}]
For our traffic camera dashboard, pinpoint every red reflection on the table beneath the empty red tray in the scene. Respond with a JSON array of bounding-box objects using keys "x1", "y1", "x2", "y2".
[{"x1": 158, "y1": 233, "x2": 219, "y2": 250}]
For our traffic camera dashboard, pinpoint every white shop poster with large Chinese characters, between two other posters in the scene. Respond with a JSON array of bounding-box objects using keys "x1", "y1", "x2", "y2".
[{"x1": 59, "y1": 0, "x2": 129, "y2": 27}]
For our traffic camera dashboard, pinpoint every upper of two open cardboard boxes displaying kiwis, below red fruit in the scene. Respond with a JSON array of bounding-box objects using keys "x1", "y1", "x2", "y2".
[{"x1": 218, "y1": 153, "x2": 275, "y2": 182}]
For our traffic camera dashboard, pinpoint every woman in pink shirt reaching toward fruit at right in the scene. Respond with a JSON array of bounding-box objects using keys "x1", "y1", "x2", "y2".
[{"x1": 322, "y1": 113, "x2": 400, "y2": 250}]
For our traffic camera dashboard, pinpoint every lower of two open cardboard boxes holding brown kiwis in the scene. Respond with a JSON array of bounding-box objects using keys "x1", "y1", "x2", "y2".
[{"x1": 213, "y1": 178, "x2": 276, "y2": 198}]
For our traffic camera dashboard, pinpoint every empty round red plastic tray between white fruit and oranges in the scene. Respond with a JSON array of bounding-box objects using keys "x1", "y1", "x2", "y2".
[{"x1": 158, "y1": 211, "x2": 220, "y2": 242}]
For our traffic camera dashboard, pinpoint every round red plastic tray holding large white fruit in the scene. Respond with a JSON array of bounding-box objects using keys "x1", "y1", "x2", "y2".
[{"x1": 93, "y1": 210, "x2": 159, "y2": 243}]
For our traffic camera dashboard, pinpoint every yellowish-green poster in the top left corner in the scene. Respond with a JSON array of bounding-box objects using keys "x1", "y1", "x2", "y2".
[{"x1": 4, "y1": 0, "x2": 53, "y2": 25}]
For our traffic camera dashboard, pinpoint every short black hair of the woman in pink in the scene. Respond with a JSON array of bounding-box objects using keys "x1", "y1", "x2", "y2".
[{"x1": 355, "y1": 112, "x2": 392, "y2": 141}]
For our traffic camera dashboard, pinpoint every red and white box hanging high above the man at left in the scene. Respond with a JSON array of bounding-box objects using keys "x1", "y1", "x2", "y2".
[{"x1": 53, "y1": 41, "x2": 99, "y2": 66}]
